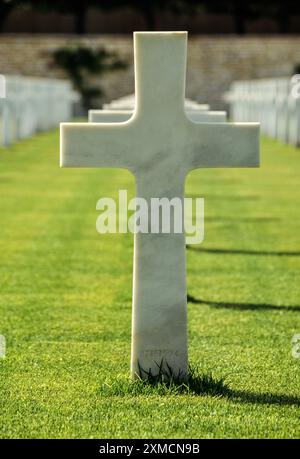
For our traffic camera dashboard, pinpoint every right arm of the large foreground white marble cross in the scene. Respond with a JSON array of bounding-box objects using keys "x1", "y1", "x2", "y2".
[{"x1": 187, "y1": 123, "x2": 259, "y2": 170}]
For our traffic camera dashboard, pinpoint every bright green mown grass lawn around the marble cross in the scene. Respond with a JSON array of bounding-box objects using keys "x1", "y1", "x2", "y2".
[{"x1": 0, "y1": 132, "x2": 300, "y2": 438}]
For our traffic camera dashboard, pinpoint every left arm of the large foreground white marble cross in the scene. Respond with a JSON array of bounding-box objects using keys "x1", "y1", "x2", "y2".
[{"x1": 60, "y1": 121, "x2": 136, "y2": 170}]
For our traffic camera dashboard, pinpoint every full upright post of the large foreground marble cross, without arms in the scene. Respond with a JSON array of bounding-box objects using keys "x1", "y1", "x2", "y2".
[{"x1": 131, "y1": 32, "x2": 187, "y2": 378}]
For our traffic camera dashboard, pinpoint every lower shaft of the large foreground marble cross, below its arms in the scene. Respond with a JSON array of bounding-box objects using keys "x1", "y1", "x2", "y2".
[{"x1": 131, "y1": 173, "x2": 188, "y2": 379}]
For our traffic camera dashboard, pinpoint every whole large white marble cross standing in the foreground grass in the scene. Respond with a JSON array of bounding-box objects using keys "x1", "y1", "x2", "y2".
[{"x1": 61, "y1": 32, "x2": 259, "y2": 379}]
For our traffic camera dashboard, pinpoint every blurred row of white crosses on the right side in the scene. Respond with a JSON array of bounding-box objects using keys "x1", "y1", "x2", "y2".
[{"x1": 225, "y1": 75, "x2": 300, "y2": 146}]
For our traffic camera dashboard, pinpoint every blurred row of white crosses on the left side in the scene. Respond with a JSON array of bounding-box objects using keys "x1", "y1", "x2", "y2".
[{"x1": 0, "y1": 76, "x2": 77, "y2": 146}]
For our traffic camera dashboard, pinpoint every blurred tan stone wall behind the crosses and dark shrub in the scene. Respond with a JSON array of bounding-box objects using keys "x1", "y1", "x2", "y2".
[{"x1": 0, "y1": 34, "x2": 300, "y2": 109}]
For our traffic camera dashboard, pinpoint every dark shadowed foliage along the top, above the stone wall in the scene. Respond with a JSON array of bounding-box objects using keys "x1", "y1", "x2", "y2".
[{"x1": 0, "y1": 0, "x2": 300, "y2": 35}]
